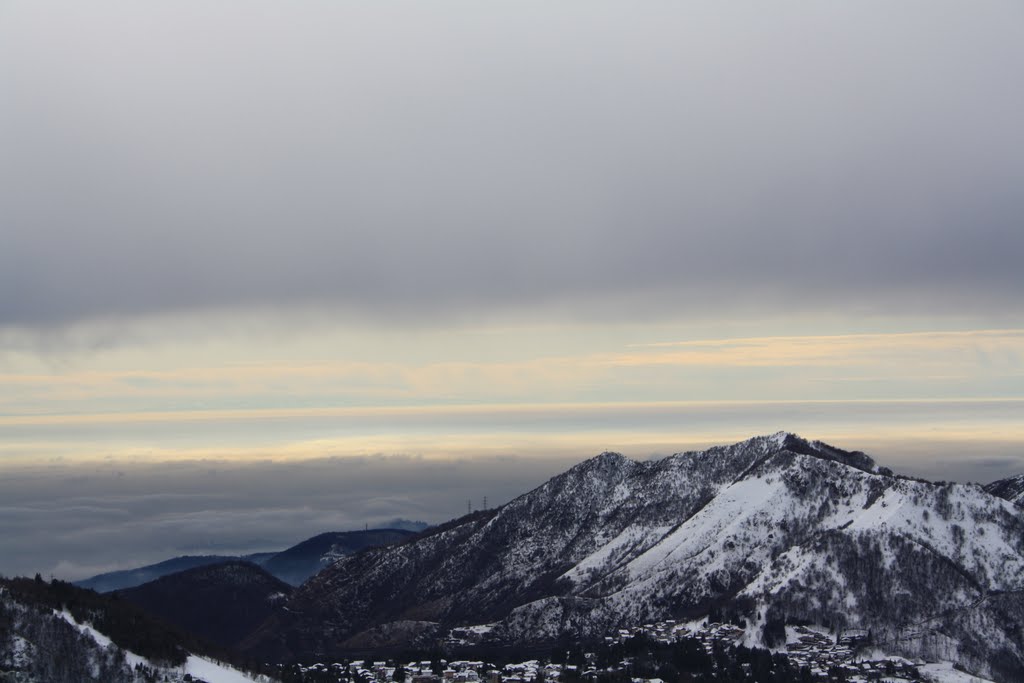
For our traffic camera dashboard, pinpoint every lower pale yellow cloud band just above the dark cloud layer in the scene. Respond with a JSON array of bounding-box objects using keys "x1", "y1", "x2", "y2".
[{"x1": 8, "y1": 399, "x2": 1024, "y2": 467}]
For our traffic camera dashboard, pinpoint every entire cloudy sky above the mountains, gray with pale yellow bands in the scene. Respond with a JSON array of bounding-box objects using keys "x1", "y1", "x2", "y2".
[{"x1": 0, "y1": 0, "x2": 1024, "y2": 579}]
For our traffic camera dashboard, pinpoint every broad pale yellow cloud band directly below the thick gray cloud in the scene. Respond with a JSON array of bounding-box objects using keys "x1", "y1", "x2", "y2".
[{"x1": 0, "y1": 330, "x2": 1024, "y2": 426}]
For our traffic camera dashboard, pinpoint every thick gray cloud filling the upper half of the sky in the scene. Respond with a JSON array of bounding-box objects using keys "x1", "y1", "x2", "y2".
[{"x1": 0, "y1": 2, "x2": 1024, "y2": 326}]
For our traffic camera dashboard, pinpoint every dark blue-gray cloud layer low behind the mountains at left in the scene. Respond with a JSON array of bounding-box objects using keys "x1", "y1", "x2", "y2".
[{"x1": 0, "y1": 456, "x2": 581, "y2": 579}]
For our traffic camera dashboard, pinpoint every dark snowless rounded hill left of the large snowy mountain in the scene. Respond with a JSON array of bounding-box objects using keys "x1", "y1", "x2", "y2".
[{"x1": 115, "y1": 560, "x2": 292, "y2": 648}]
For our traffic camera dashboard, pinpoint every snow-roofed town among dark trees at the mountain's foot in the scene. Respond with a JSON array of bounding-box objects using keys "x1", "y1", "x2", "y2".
[{"x1": 274, "y1": 621, "x2": 924, "y2": 683}]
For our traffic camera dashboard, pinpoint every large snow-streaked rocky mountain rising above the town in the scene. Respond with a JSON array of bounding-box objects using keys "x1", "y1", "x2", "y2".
[{"x1": 243, "y1": 433, "x2": 1024, "y2": 681}]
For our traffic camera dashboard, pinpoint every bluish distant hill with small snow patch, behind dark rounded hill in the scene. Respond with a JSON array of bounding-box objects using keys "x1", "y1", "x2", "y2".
[{"x1": 263, "y1": 528, "x2": 415, "y2": 586}]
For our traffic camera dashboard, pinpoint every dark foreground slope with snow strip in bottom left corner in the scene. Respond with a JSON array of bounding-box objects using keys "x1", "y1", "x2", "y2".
[{"x1": 0, "y1": 575, "x2": 270, "y2": 683}]
